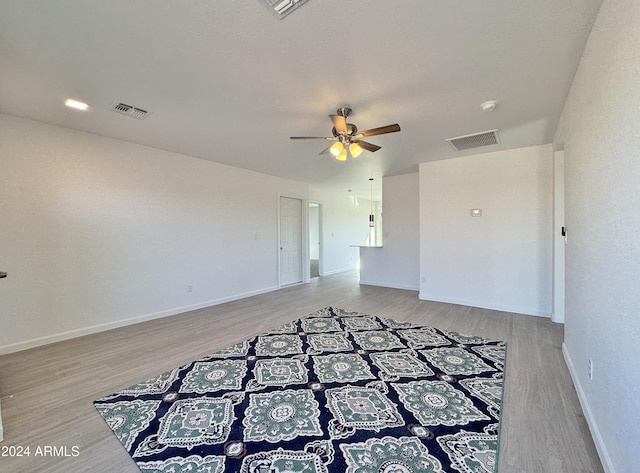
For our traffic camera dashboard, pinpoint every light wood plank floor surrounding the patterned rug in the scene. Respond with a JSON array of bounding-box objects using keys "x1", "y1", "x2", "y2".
[{"x1": 0, "y1": 272, "x2": 603, "y2": 473}]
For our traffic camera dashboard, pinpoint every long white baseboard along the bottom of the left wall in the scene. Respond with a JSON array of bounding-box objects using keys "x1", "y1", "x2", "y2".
[{"x1": 0, "y1": 286, "x2": 279, "y2": 355}]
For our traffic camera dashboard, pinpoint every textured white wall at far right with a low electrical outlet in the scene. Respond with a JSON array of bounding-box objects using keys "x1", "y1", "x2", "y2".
[{"x1": 561, "y1": 0, "x2": 640, "y2": 473}]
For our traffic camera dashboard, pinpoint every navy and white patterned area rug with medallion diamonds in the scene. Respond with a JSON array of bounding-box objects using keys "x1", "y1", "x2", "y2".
[{"x1": 94, "y1": 307, "x2": 506, "y2": 473}]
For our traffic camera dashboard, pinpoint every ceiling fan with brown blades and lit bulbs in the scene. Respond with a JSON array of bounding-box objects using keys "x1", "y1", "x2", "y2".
[{"x1": 290, "y1": 107, "x2": 400, "y2": 161}]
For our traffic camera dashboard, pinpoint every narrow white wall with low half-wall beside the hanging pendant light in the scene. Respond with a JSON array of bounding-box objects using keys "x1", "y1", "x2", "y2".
[{"x1": 360, "y1": 173, "x2": 420, "y2": 291}]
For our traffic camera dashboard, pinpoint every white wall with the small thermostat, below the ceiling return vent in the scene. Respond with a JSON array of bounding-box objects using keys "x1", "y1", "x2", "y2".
[{"x1": 419, "y1": 145, "x2": 553, "y2": 316}]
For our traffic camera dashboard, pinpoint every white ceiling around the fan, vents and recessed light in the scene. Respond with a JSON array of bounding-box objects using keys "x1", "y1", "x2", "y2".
[{"x1": 0, "y1": 0, "x2": 601, "y2": 196}]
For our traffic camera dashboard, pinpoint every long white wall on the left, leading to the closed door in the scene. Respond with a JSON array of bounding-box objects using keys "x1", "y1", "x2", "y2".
[{"x1": 0, "y1": 114, "x2": 310, "y2": 353}]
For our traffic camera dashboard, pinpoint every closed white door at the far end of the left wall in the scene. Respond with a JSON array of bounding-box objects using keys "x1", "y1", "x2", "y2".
[{"x1": 280, "y1": 197, "x2": 302, "y2": 286}]
